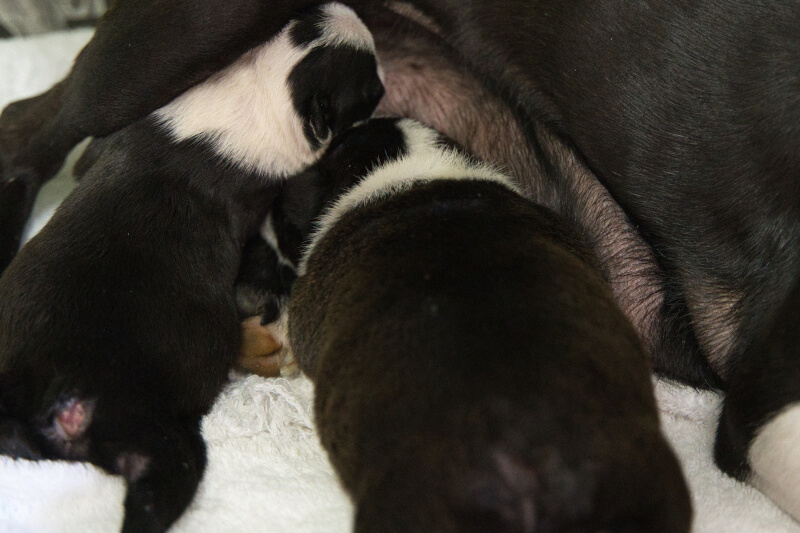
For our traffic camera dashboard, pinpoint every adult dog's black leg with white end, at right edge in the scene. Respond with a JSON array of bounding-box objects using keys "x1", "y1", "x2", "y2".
[{"x1": 715, "y1": 278, "x2": 800, "y2": 520}]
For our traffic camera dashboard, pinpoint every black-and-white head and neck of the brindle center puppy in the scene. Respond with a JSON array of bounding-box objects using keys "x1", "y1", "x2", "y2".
[{"x1": 236, "y1": 118, "x2": 499, "y2": 322}]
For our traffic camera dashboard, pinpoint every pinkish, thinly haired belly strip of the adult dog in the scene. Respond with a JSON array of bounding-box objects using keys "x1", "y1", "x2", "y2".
[{"x1": 365, "y1": 8, "x2": 692, "y2": 382}]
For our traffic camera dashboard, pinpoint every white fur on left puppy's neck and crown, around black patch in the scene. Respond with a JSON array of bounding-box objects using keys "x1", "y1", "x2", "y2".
[{"x1": 154, "y1": 4, "x2": 374, "y2": 178}]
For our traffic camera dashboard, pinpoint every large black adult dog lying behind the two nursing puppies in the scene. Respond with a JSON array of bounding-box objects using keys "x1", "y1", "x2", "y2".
[{"x1": 0, "y1": 0, "x2": 800, "y2": 528}]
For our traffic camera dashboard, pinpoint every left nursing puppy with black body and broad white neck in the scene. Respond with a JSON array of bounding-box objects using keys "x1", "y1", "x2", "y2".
[{"x1": 0, "y1": 4, "x2": 382, "y2": 532}]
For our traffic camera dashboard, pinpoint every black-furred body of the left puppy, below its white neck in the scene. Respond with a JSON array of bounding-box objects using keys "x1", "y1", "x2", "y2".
[{"x1": 0, "y1": 120, "x2": 277, "y2": 531}]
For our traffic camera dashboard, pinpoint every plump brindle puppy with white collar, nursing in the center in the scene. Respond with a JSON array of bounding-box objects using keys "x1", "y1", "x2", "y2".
[{"x1": 258, "y1": 119, "x2": 691, "y2": 533}]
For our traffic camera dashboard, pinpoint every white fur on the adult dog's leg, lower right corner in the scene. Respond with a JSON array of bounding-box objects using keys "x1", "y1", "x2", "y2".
[{"x1": 748, "y1": 403, "x2": 800, "y2": 521}]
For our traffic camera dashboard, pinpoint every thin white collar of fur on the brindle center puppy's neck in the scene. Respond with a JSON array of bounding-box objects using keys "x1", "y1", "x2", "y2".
[{"x1": 298, "y1": 119, "x2": 520, "y2": 275}]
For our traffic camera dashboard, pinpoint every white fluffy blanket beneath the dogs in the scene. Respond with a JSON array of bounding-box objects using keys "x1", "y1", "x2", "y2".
[{"x1": 0, "y1": 30, "x2": 800, "y2": 533}]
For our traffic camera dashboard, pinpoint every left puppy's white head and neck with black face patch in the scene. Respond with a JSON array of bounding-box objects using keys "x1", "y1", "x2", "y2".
[{"x1": 154, "y1": 4, "x2": 383, "y2": 178}]
